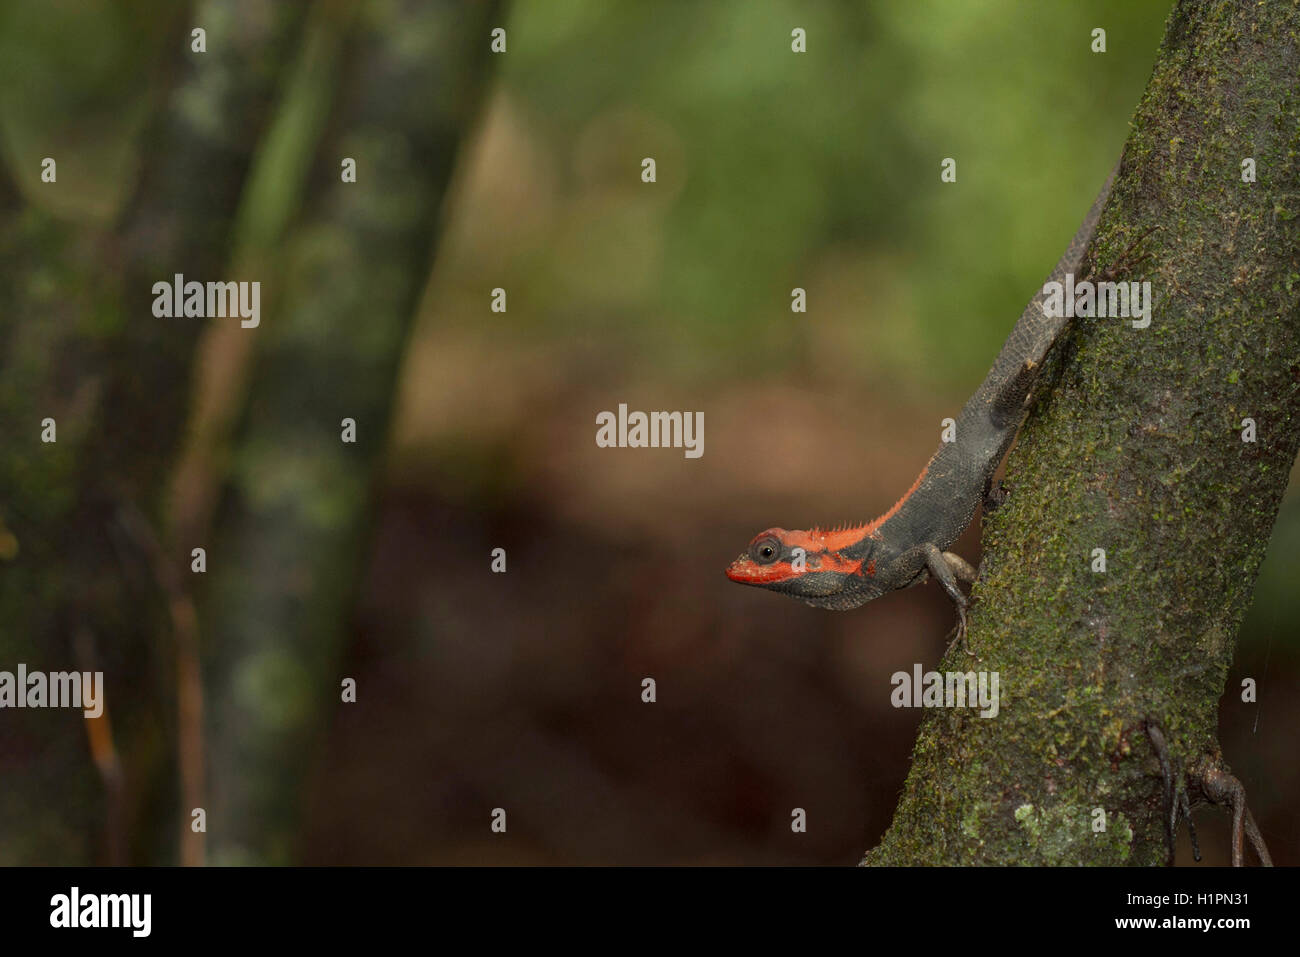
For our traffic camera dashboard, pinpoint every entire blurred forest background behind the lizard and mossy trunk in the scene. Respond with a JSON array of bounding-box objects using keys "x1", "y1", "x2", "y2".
[{"x1": 0, "y1": 0, "x2": 1300, "y2": 863}]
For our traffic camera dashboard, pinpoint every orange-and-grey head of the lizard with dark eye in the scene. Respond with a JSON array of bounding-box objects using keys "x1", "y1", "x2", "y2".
[{"x1": 727, "y1": 527, "x2": 875, "y2": 607}]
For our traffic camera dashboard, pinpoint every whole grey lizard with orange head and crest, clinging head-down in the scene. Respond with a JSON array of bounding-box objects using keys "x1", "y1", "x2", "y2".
[{"x1": 727, "y1": 163, "x2": 1131, "y2": 654}]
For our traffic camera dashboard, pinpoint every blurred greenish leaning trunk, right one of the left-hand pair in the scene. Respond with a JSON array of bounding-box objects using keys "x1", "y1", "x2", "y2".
[{"x1": 189, "y1": 3, "x2": 498, "y2": 863}]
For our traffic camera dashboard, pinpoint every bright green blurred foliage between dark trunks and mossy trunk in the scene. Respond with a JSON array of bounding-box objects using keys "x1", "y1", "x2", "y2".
[{"x1": 478, "y1": 0, "x2": 1167, "y2": 394}]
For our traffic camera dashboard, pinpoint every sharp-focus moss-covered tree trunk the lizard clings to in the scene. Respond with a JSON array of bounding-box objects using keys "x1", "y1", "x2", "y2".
[{"x1": 863, "y1": 0, "x2": 1300, "y2": 865}]
